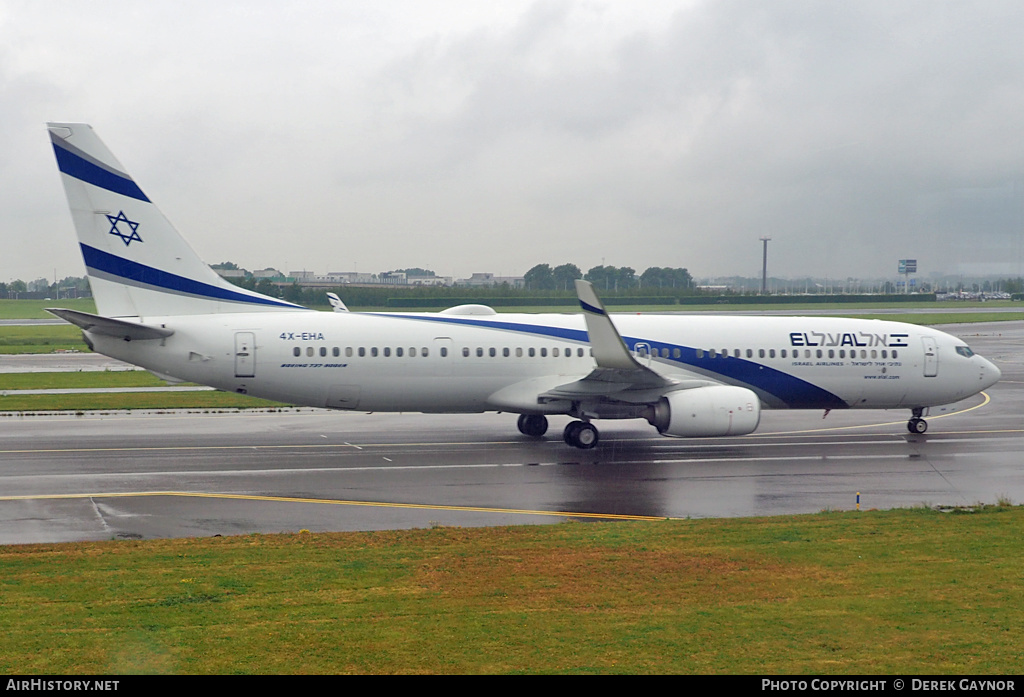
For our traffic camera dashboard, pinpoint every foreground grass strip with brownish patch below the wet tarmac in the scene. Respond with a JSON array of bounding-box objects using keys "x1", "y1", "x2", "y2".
[{"x1": 0, "y1": 504, "x2": 1024, "y2": 674}]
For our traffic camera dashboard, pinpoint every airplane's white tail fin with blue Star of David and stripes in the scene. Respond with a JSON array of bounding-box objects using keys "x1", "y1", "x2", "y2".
[{"x1": 47, "y1": 123, "x2": 305, "y2": 317}]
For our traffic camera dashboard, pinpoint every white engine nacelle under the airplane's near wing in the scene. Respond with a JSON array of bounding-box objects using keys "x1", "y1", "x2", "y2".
[{"x1": 647, "y1": 385, "x2": 761, "y2": 438}]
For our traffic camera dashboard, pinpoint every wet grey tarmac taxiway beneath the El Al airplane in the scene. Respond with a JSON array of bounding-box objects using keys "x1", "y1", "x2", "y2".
[{"x1": 0, "y1": 322, "x2": 1024, "y2": 543}]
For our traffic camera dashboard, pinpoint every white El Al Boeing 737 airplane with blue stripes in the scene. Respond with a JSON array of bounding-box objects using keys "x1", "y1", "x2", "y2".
[{"x1": 49, "y1": 124, "x2": 999, "y2": 448}]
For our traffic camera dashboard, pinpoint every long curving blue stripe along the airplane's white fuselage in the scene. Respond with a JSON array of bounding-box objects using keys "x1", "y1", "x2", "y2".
[{"x1": 391, "y1": 315, "x2": 850, "y2": 409}]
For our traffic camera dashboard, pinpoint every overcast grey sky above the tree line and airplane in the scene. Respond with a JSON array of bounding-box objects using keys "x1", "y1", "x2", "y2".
[{"x1": 0, "y1": 0, "x2": 1024, "y2": 280}]
